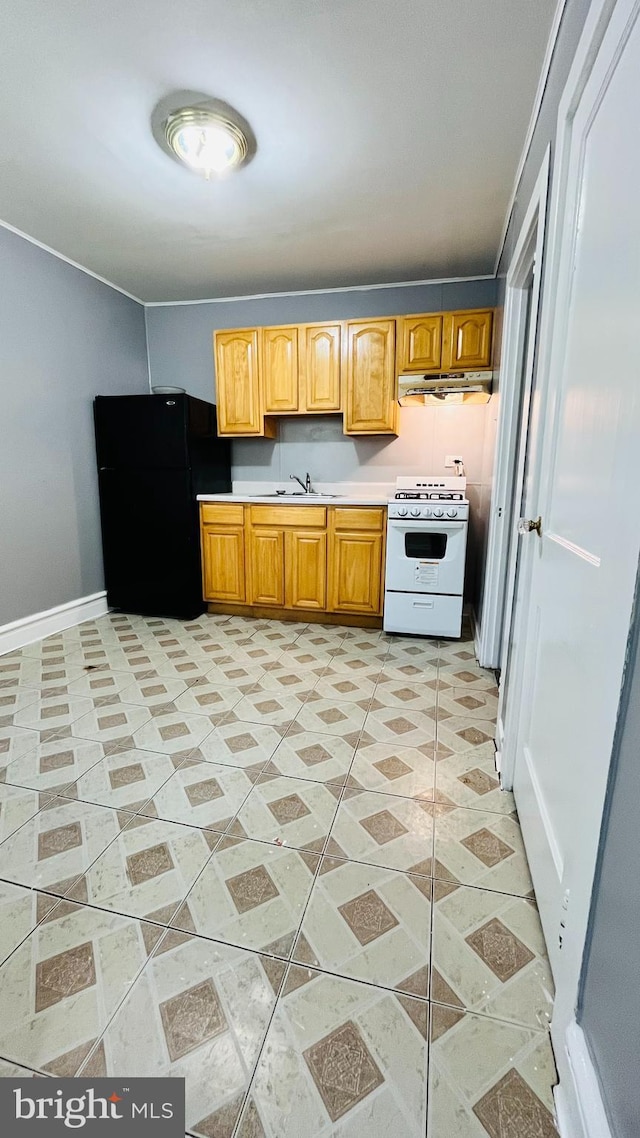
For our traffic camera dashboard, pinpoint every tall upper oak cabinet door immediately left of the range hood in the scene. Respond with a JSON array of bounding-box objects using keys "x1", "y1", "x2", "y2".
[{"x1": 344, "y1": 320, "x2": 397, "y2": 435}]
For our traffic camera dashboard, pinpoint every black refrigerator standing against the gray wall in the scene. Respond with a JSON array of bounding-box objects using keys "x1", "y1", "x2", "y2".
[{"x1": 93, "y1": 395, "x2": 231, "y2": 619}]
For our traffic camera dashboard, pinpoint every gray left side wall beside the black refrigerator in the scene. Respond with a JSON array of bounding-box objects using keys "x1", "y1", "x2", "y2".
[{"x1": 0, "y1": 229, "x2": 148, "y2": 625}]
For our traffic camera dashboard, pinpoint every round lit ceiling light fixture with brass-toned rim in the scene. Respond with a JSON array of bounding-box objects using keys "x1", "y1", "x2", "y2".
[{"x1": 164, "y1": 105, "x2": 249, "y2": 179}]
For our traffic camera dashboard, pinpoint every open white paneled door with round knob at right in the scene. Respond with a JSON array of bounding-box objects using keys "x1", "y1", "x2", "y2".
[{"x1": 503, "y1": 0, "x2": 640, "y2": 1026}]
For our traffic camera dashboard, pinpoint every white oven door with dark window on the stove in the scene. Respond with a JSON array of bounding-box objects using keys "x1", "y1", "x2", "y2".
[{"x1": 385, "y1": 518, "x2": 467, "y2": 596}]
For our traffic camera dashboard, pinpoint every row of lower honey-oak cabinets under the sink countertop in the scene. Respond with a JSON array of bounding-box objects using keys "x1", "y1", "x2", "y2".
[{"x1": 200, "y1": 502, "x2": 385, "y2": 618}]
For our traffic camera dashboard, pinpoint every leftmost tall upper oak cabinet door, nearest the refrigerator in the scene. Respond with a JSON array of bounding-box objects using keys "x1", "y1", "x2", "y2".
[{"x1": 214, "y1": 328, "x2": 264, "y2": 435}]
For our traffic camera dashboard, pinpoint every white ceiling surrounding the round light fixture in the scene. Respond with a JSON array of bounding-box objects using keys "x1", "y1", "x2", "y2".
[{"x1": 0, "y1": 0, "x2": 556, "y2": 300}]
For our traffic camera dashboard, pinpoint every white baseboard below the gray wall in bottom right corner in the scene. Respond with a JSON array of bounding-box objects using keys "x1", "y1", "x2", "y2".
[{"x1": 553, "y1": 1020, "x2": 613, "y2": 1138}]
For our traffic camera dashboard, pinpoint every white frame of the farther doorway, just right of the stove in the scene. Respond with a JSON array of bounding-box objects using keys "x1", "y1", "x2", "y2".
[{"x1": 475, "y1": 147, "x2": 551, "y2": 673}]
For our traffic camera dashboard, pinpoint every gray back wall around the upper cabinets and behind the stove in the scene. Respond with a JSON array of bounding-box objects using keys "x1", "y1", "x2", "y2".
[{"x1": 146, "y1": 280, "x2": 495, "y2": 601}]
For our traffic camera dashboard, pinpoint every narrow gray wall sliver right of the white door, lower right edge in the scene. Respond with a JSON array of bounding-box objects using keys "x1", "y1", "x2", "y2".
[{"x1": 577, "y1": 564, "x2": 640, "y2": 1138}]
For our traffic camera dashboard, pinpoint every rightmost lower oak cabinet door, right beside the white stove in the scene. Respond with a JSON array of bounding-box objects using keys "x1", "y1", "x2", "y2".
[{"x1": 329, "y1": 530, "x2": 383, "y2": 617}]
